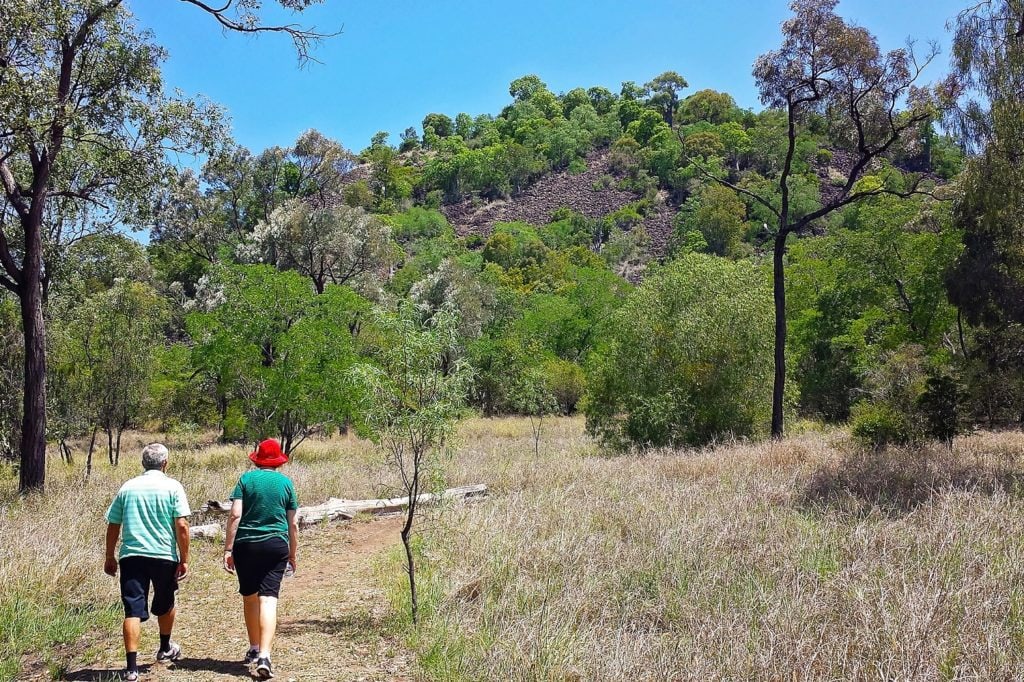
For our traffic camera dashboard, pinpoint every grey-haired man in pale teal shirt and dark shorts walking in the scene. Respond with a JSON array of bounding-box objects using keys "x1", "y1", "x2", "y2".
[{"x1": 103, "y1": 443, "x2": 191, "y2": 682}]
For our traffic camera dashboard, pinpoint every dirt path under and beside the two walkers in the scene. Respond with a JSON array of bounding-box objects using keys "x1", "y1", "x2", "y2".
[{"x1": 65, "y1": 517, "x2": 412, "y2": 682}]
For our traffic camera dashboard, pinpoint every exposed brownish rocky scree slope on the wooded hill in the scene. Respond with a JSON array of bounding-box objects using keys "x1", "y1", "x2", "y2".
[{"x1": 441, "y1": 153, "x2": 676, "y2": 256}]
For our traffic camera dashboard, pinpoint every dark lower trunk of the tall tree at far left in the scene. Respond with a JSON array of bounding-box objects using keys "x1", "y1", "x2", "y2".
[{"x1": 19, "y1": 274, "x2": 46, "y2": 493}]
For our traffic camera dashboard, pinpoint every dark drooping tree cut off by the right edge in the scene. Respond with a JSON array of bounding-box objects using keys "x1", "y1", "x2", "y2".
[{"x1": 946, "y1": 0, "x2": 1024, "y2": 424}]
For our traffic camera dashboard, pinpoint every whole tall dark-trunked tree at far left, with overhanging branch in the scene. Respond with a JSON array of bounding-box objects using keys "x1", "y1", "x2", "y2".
[{"x1": 0, "y1": 0, "x2": 323, "y2": 491}]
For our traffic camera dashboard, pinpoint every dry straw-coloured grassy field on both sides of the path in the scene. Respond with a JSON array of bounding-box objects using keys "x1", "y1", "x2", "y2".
[{"x1": 0, "y1": 419, "x2": 1024, "y2": 680}]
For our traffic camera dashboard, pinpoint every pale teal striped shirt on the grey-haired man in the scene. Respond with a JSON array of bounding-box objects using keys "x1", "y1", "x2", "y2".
[{"x1": 106, "y1": 469, "x2": 191, "y2": 561}]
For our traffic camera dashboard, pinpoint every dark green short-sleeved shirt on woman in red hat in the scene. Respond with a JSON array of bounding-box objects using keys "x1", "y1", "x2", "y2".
[{"x1": 231, "y1": 469, "x2": 299, "y2": 543}]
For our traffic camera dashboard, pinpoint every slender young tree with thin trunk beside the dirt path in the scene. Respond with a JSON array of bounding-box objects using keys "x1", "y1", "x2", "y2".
[{"x1": 355, "y1": 306, "x2": 469, "y2": 623}]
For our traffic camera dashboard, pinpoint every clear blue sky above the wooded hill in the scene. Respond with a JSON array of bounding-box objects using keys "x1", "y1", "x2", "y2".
[{"x1": 130, "y1": 0, "x2": 965, "y2": 152}]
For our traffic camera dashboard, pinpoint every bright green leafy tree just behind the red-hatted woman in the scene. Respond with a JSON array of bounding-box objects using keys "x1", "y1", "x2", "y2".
[{"x1": 187, "y1": 265, "x2": 370, "y2": 451}]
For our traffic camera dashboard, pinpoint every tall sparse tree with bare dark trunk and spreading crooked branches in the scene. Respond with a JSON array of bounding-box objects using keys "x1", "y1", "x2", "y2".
[{"x1": 690, "y1": 0, "x2": 951, "y2": 437}]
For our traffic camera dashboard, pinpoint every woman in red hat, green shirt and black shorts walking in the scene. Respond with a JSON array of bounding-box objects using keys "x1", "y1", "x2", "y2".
[{"x1": 224, "y1": 439, "x2": 299, "y2": 680}]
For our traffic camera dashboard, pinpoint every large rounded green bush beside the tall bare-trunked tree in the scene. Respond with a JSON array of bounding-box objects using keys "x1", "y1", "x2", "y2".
[{"x1": 585, "y1": 254, "x2": 772, "y2": 447}]
